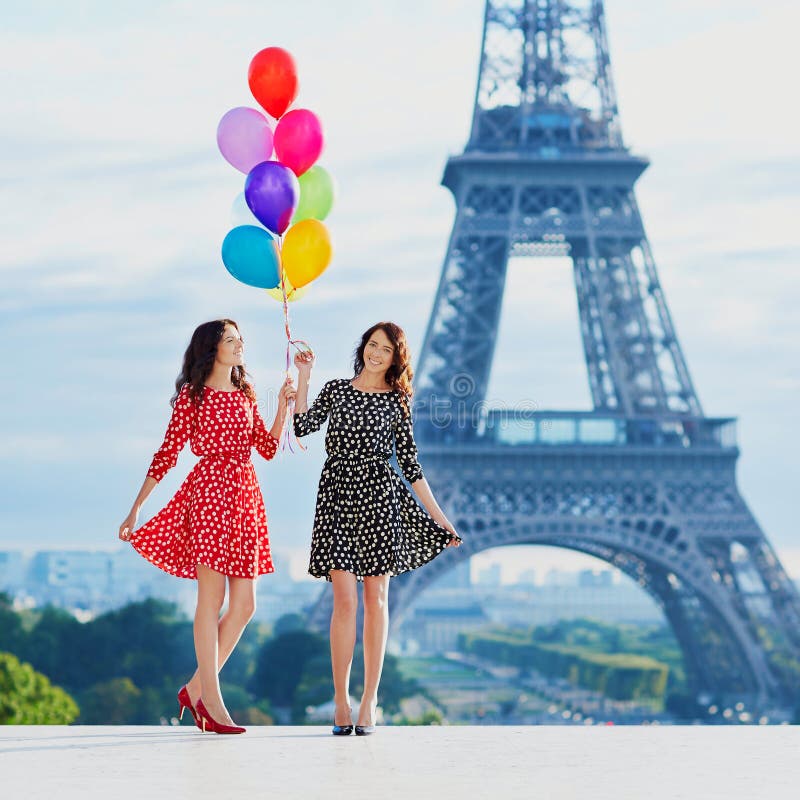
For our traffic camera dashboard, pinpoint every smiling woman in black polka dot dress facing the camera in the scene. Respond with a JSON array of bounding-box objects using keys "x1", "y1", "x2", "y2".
[{"x1": 294, "y1": 322, "x2": 461, "y2": 735}]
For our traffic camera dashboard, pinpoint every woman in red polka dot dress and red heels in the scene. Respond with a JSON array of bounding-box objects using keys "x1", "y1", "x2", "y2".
[{"x1": 119, "y1": 319, "x2": 295, "y2": 733}]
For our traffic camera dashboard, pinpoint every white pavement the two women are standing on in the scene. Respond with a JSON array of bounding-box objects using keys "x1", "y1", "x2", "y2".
[{"x1": 0, "y1": 726, "x2": 800, "y2": 800}]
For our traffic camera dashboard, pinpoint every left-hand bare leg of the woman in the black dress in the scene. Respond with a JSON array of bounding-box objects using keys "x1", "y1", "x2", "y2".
[{"x1": 331, "y1": 569, "x2": 358, "y2": 725}]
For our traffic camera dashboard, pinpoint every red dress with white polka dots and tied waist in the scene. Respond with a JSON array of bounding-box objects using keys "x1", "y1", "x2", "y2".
[{"x1": 131, "y1": 384, "x2": 278, "y2": 578}]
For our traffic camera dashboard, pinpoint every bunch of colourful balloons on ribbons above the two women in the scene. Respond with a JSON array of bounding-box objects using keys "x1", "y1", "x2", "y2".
[{"x1": 217, "y1": 47, "x2": 334, "y2": 454}]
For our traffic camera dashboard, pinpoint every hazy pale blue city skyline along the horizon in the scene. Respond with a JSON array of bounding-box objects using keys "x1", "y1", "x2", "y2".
[{"x1": 0, "y1": 546, "x2": 664, "y2": 636}]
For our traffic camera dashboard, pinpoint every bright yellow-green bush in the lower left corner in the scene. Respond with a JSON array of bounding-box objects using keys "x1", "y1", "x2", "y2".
[{"x1": 0, "y1": 653, "x2": 78, "y2": 725}]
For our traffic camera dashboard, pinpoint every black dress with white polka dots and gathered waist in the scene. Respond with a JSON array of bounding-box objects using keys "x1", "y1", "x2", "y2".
[{"x1": 294, "y1": 378, "x2": 451, "y2": 580}]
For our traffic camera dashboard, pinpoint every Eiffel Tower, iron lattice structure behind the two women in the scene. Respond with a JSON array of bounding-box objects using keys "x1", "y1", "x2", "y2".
[{"x1": 312, "y1": 0, "x2": 800, "y2": 708}]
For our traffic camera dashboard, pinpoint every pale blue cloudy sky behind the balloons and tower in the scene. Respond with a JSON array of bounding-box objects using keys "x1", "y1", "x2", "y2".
[{"x1": 0, "y1": 0, "x2": 800, "y2": 577}]
